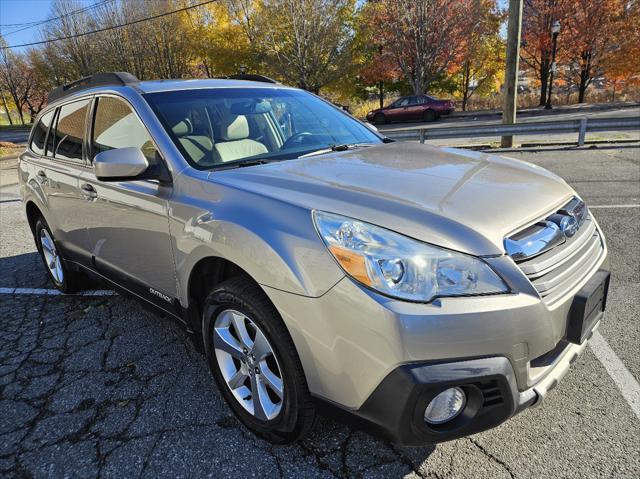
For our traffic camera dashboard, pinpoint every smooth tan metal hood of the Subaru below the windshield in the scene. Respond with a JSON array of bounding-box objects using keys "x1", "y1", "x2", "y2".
[{"x1": 209, "y1": 142, "x2": 574, "y2": 255}]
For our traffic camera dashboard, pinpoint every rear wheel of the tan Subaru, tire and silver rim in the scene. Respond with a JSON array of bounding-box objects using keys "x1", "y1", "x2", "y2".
[{"x1": 34, "y1": 216, "x2": 84, "y2": 294}]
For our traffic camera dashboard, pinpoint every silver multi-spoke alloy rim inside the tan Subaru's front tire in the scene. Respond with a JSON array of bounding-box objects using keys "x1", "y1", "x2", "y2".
[{"x1": 213, "y1": 309, "x2": 284, "y2": 421}]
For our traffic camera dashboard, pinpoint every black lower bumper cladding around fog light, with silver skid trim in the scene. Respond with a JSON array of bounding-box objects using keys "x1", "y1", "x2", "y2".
[{"x1": 318, "y1": 322, "x2": 600, "y2": 445}]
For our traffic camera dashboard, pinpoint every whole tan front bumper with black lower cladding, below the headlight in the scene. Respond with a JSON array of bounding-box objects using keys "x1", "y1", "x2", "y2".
[{"x1": 264, "y1": 227, "x2": 609, "y2": 444}]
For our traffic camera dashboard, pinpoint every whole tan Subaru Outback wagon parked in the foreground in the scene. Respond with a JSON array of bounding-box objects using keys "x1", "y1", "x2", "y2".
[{"x1": 19, "y1": 73, "x2": 609, "y2": 444}]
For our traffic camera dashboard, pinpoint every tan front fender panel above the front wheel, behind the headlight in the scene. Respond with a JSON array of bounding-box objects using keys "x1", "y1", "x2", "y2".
[{"x1": 170, "y1": 177, "x2": 344, "y2": 305}]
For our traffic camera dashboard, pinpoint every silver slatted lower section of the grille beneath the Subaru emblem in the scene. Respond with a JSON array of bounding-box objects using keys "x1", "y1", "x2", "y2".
[{"x1": 514, "y1": 201, "x2": 604, "y2": 305}]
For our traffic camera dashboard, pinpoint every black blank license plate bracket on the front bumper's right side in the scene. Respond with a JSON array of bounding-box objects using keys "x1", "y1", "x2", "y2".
[{"x1": 567, "y1": 269, "x2": 611, "y2": 344}]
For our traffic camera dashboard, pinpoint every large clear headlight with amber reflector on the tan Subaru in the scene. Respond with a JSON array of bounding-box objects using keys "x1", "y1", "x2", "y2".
[{"x1": 313, "y1": 211, "x2": 509, "y2": 302}]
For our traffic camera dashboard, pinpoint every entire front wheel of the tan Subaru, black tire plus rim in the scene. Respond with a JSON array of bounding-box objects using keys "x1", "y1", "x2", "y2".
[{"x1": 202, "y1": 277, "x2": 315, "y2": 444}]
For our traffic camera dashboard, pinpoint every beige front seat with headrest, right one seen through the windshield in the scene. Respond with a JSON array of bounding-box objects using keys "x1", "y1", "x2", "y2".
[{"x1": 214, "y1": 115, "x2": 268, "y2": 162}]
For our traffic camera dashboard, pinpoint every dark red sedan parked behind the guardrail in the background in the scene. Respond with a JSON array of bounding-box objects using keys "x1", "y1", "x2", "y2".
[{"x1": 367, "y1": 95, "x2": 455, "y2": 125}]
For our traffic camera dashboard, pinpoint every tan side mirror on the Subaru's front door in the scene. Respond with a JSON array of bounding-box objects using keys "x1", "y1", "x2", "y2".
[{"x1": 93, "y1": 146, "x2": 149, "y2": 181}]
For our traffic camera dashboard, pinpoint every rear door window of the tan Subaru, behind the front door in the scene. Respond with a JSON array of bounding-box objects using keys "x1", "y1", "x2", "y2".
[{"x1": 53, "y1": 100, "x2": 90, "y2": 161}]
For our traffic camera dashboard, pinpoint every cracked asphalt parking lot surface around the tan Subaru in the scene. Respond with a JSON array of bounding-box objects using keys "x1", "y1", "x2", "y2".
[{"x1": 0, "y1": 144, "x2": 640, "y2": 478}]
